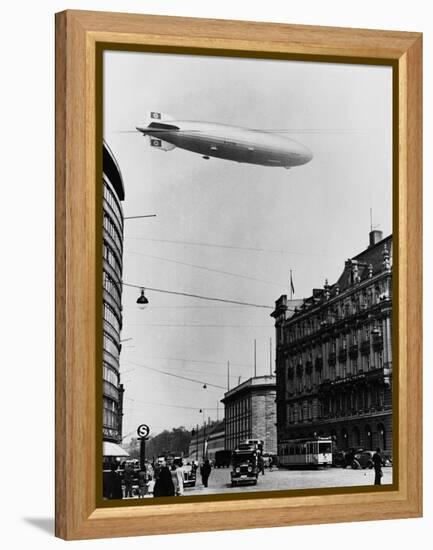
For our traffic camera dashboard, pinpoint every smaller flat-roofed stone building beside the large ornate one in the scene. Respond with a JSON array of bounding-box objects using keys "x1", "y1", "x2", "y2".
[{"x1": 221, "y1": 376, "x2": 277, "y2": 454}]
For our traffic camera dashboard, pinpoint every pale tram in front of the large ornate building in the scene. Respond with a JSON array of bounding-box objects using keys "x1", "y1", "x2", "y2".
[{"x1": 278, "y1": 437, "x2": 333, "y2": 468}]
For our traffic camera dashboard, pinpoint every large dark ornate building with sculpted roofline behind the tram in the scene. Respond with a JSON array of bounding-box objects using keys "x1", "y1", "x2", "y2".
[{"x1": 272, "y1": 231, "x2": 392, "y2": 454}]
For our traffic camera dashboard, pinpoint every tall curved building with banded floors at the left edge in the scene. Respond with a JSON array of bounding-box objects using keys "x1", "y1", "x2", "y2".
[{"x1": 102, "y1": 143, "x2": 125, "y2": 443}]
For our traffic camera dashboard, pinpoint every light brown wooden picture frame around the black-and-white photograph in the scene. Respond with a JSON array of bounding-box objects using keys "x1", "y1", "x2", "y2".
[{"x1": 56, "y1": 11, "x2": 422, "y2": 540}]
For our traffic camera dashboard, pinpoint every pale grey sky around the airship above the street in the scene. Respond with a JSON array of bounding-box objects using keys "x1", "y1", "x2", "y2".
[{"x1": 103, "y1": 52, "x2": 392, "y2": 441}]
